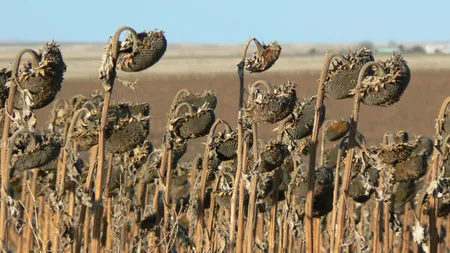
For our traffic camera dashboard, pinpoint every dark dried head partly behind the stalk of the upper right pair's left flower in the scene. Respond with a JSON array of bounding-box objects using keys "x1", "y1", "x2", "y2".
[{"x1": 283, "y1": 96, "x2": 326, "y2": 140}]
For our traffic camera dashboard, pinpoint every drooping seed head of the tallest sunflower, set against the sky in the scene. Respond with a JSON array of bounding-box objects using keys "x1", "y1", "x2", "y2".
[{"x1": 117, "y1": 30, "x2": 167, "y2": 72}]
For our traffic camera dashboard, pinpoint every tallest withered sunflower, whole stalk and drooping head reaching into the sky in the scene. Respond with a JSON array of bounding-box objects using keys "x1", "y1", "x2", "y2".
[{"x1": 92, "y1": 26, "x2": 167, "y2": 252}]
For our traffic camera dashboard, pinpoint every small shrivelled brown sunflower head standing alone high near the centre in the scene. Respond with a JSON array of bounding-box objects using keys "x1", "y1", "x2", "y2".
[{"x1": 245, "y1": 39, "x2": 281, "y2": 73}]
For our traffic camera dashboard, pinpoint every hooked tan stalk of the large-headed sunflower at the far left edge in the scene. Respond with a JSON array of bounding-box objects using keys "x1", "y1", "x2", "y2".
[{"x1": 0, "y1": 49, "x2": 39, "y2": 251}]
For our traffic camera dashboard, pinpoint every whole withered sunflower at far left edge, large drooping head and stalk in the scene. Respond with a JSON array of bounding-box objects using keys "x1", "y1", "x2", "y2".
[{"x1": 0, "y1": 42, "x2": 66, "y2": 249}]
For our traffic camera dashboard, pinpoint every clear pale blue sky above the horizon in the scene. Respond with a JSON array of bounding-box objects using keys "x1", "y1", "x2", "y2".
[{"x1": 0, "y1": 0, "x2": 450, "y2": 44}]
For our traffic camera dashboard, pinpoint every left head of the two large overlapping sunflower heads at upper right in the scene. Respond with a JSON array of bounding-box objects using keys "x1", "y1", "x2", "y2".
[{"x1": 324, "y1": 48, "x2": 374, "y2": 99}]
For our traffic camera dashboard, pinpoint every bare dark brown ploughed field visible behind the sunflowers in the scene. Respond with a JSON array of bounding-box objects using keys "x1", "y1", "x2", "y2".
[{"x1": 32, "y1": 68, "x2": 450, "y2": 159}]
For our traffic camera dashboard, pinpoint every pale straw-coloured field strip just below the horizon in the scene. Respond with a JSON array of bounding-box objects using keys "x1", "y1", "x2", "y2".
[{"x1": 0, "y1": 43, "x2": 450, "y2": 78}]
